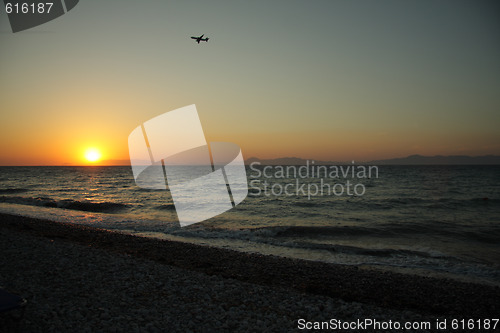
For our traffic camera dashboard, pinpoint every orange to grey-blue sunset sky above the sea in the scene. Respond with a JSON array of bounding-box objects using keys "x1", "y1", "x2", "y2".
[{"x1": 0, "y1": 0, "x2": 500, "y2": 165}]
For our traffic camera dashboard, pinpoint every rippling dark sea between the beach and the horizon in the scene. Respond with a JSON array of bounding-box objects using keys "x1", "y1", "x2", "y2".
[{"x1": 0, "y1": 165, "x2": 500, "y2": 285}]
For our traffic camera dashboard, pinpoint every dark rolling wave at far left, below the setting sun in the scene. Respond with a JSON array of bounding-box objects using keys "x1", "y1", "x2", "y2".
[{"x1": 0, "y1": 196, "x2": 130, "y2": 213}]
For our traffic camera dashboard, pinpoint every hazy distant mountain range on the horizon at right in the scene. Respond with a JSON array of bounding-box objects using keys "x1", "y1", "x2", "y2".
[{"x1": 245, "y1": 155, "x2": 500, "y2": 165}]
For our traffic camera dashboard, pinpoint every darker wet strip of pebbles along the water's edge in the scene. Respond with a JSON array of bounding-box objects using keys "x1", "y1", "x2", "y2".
[{"x1": 0, "y1": 214, "x2": 500, "y2": 318}]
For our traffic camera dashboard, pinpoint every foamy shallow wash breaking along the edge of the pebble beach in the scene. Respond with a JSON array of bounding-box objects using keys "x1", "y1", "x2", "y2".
[{"x1": 0, "y1": 203, "x2": 500, "y2": 285}]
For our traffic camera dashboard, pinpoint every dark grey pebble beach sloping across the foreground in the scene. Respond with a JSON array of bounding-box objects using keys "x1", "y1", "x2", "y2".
[{"x1": 0, "y1": 214, "x2": 500, "y2": 332}]
